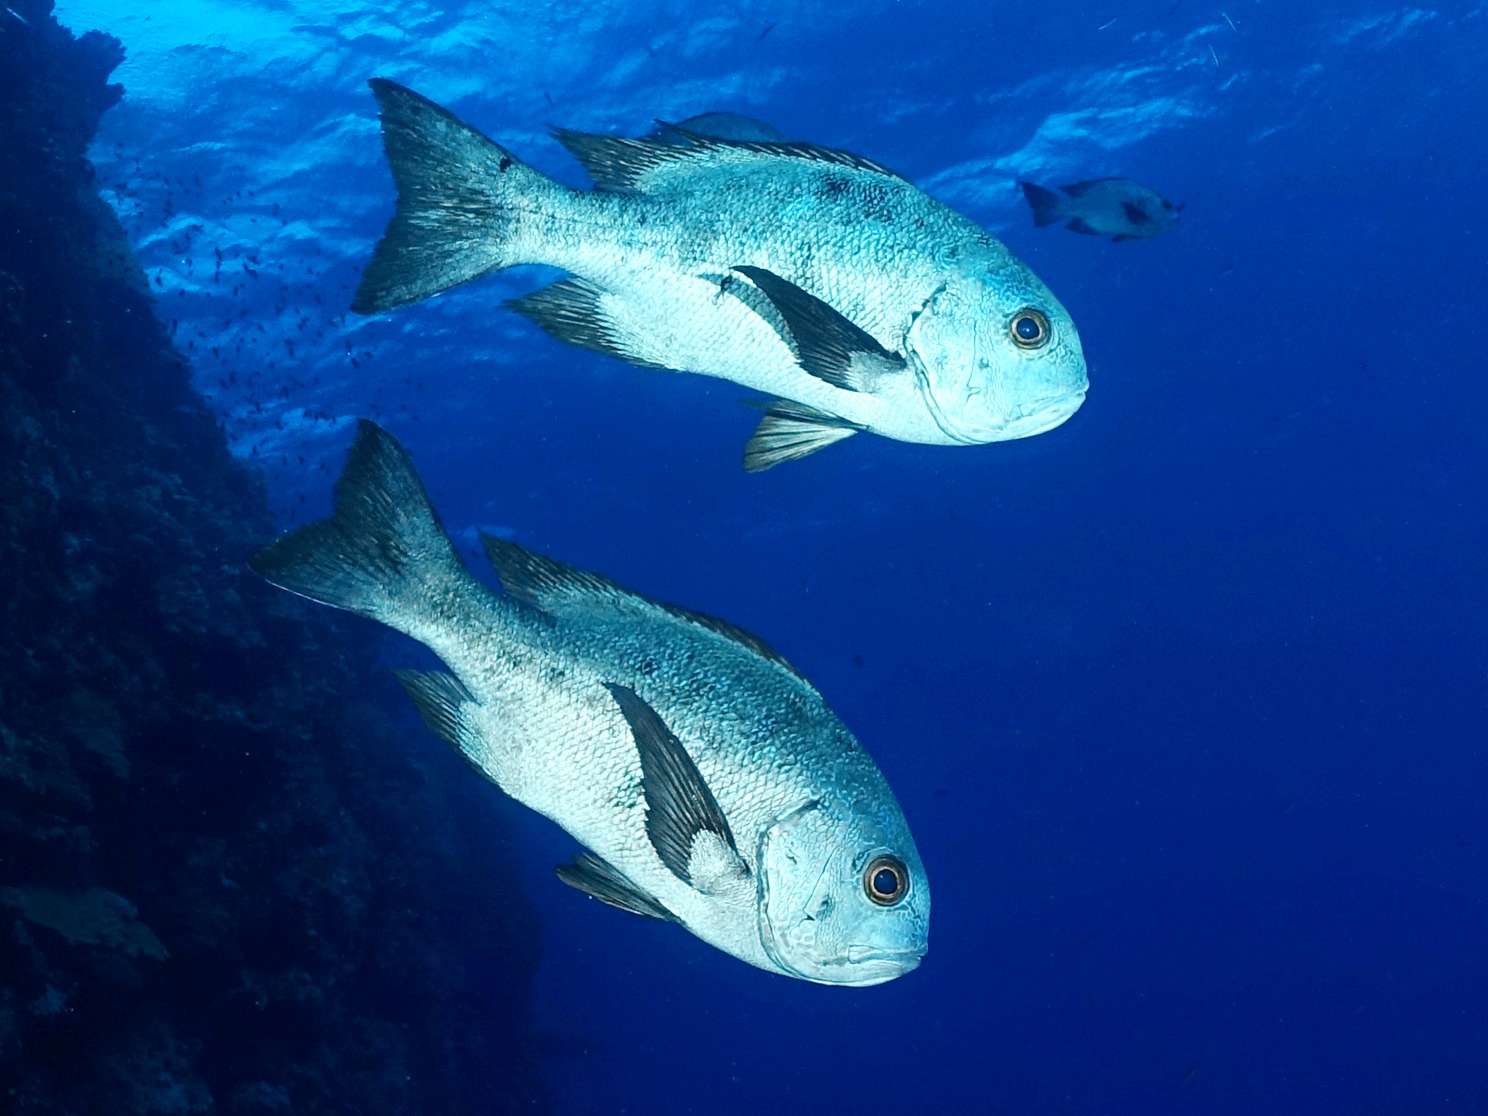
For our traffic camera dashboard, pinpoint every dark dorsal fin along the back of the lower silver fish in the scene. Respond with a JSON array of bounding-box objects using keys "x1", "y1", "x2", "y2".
[{"x1": 481, "y1": 534, "x2": 811, "y2": 686}]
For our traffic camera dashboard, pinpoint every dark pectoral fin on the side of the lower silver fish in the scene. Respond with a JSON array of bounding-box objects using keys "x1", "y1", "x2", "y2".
[{"x1": 606, "y1": 683, "x2": 747, "y2": 884}]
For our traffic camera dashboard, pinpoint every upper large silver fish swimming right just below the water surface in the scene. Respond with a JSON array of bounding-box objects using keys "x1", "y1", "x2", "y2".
[{"x1": 353, "y1": 79, "x2": 1086, "y2": 470}]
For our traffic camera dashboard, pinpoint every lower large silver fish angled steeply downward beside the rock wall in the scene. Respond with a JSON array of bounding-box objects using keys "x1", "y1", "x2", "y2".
[{"x1": 250, "y1": 421, "x2": 930, "y2": 985}]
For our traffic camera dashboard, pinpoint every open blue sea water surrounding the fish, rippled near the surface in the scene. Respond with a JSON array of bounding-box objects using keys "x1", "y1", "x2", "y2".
[{"x1": 46, "y1": 0, "x2": 1488, "y2": 1113}]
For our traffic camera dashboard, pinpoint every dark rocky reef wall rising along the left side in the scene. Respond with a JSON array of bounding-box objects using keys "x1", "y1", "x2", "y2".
[{"x1": 0, "y1": 0, "x2": 545, "y2": 1115}]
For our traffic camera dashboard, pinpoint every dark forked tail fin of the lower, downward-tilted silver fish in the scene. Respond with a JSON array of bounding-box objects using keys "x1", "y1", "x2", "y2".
[{"x1": 248, "y1": 418, "x2": 470, "y2": 635}]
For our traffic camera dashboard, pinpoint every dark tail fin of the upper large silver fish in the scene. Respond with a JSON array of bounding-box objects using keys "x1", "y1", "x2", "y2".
[{"x1": 351, "y1": 77, "x2": 559, "y2": 314}]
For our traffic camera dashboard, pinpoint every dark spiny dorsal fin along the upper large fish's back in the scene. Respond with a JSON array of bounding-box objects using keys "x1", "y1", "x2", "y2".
[{"x1": 554, "y1": 124, "x2": 902, "y2": 190}]
